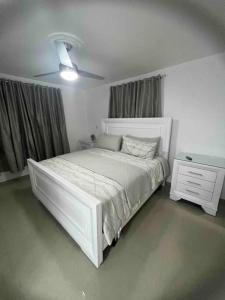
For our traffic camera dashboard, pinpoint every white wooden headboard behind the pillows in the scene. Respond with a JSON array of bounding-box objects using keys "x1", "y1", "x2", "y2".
[{"x1": 102, "y1": 118, "x2": 172, "y2": 159}]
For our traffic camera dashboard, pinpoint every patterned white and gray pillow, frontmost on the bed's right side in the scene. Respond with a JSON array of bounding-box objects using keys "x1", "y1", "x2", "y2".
[{"x1": 121, "y1": 136, "x2": 157, "y2": 159}]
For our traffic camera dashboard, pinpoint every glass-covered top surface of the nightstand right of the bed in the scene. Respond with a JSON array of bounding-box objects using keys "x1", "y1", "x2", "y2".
[{"x1": 175, "y1": 152, "x2": 225, "y2": 169}]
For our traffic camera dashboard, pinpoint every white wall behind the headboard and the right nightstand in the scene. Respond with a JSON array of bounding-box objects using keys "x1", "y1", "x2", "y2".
[{"x1": 83, "y1": 53, "x2": 225, "y2": 198}]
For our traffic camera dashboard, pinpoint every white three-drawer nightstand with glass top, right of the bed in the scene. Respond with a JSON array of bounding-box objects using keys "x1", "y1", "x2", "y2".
[{"x1": 170, "y1": 153, "x2": 225, "y2": 216}]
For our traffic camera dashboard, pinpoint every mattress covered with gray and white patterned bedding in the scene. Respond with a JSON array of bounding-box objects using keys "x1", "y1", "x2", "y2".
[{"x1": 40, "y1": 148, "x2": 168, "y2": 245}]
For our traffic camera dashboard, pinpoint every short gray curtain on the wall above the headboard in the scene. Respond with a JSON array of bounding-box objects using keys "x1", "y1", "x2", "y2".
[{"x1": 109, "y1": 76, "x2": 162, "y2": 118}]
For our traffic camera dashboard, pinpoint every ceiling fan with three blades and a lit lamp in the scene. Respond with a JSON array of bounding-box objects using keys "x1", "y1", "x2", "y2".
[{"x1": 34, "y1": 40, "x2": 104, "y2": 81}]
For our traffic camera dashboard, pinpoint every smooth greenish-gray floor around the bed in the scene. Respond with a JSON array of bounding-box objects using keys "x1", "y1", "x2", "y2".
[{"x1": 0, "y1": 177, "x2": 225, "y2": 300}]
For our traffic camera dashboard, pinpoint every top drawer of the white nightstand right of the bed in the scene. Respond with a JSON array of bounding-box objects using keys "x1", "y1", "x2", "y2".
[{"x1": 178, "y1": 165, "x2": 216, "y2": 182}]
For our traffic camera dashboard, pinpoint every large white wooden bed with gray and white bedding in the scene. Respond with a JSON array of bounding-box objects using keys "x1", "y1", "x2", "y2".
[{"x1": 28, "y1": 118, "x2": 172, "y2": 267}]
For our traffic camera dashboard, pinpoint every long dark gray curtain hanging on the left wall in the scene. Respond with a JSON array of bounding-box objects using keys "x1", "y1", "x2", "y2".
[{"x1": 0, "y1": 79, "x2": 69, "y2": 172}]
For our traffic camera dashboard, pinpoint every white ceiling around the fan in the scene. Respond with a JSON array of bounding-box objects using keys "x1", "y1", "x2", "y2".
[{"x1": 0, "y1": 0, "x2": 225, "y2": 88}]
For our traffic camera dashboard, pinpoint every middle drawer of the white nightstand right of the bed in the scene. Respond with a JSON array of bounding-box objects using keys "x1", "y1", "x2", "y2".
[{"x1": 177, "y1": 174, "x2": 215, "y2": 192}]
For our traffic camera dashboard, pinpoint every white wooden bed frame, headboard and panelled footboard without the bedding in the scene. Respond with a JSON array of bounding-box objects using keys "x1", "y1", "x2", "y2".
[{"x1": 28, "y1": 118, "x2": 172, "y2": 268}]
